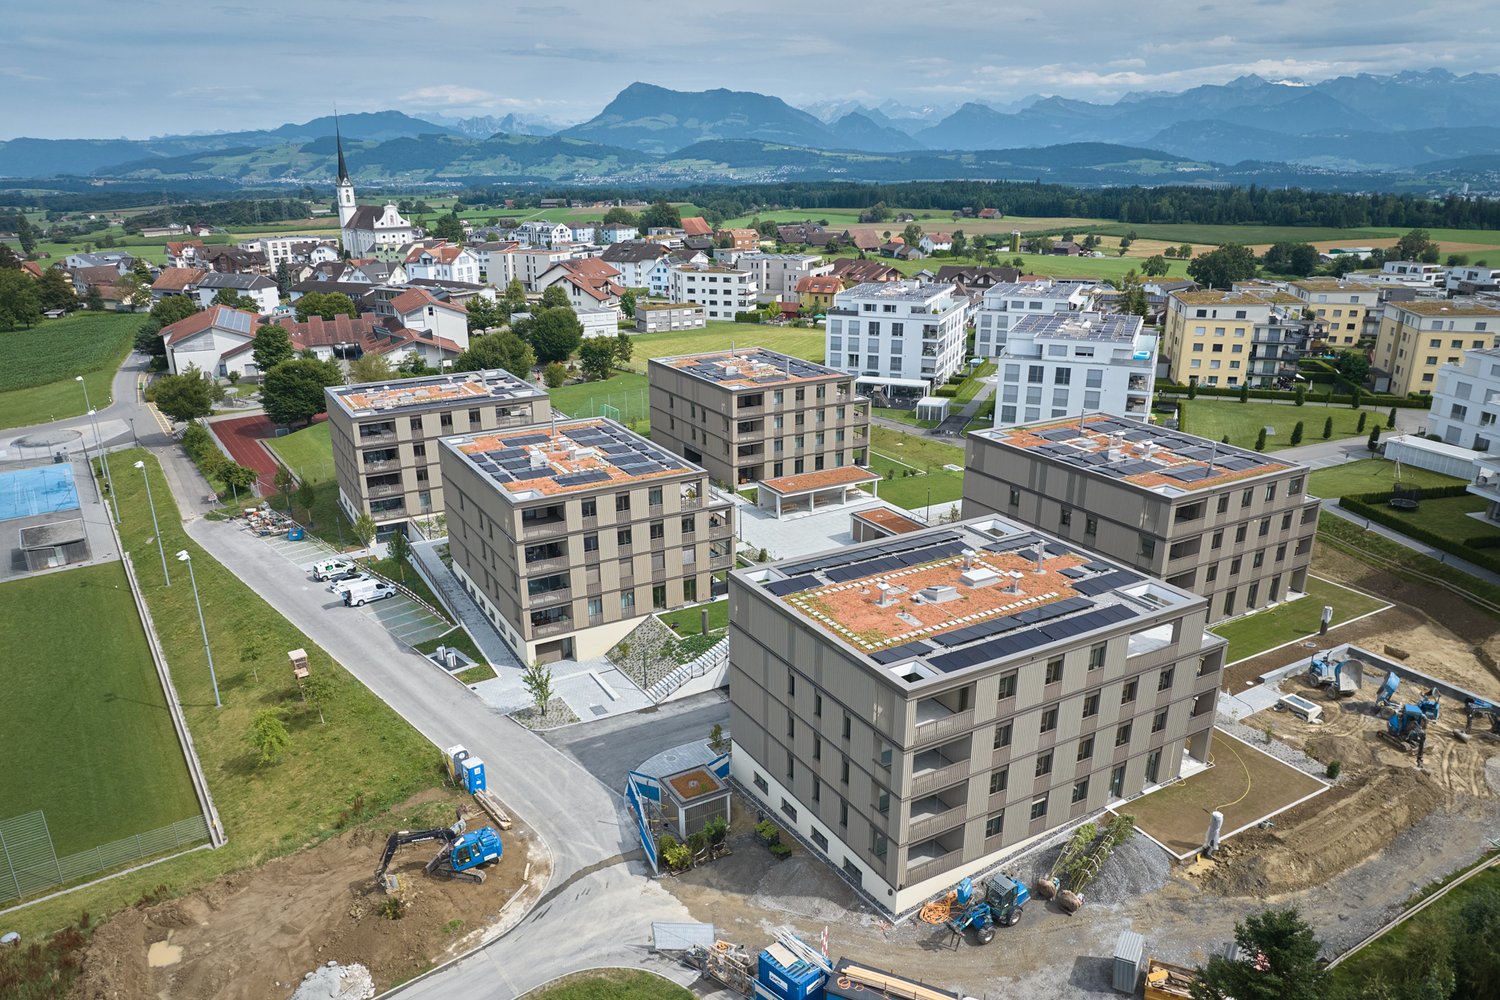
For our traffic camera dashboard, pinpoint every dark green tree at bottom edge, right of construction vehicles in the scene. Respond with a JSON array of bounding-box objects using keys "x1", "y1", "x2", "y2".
[{"x1": 1193, "y1": 907, "x2": 1328, "y2": 1000}]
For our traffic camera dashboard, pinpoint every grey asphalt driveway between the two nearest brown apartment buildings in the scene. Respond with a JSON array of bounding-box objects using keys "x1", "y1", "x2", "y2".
[{"x1": 543, "y1": 690, "x2": 729, "y2": 790}]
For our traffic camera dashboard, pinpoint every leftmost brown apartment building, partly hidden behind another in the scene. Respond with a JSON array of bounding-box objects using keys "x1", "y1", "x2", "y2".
[{"x1": 324, "y1": 369, "x2": 552, "y2": 528}]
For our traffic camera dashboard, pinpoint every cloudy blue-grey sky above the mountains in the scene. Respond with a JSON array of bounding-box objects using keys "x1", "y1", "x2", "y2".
[{"x1": 0, "y1": 0, "x2": 1500, "y2": 139}]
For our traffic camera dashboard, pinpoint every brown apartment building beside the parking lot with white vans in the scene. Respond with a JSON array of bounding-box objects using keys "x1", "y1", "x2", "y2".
[{"x1": 440, "y1": 418, "x2": 735, "y2": 663}]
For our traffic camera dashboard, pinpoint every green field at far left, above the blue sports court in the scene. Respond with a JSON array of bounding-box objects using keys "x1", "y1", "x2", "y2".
[{"x1": 0, "y1": 312, "x2": 146, "y2": 427}]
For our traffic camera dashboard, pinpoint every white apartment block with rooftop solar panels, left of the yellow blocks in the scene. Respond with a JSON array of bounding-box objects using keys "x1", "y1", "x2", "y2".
[{"x1": 995, "y1": 312, "x2": 1157, "y2": 426}]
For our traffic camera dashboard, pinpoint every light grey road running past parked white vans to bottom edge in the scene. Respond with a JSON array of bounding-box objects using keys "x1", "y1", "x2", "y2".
[{"x1": 188, "y1": 520, "x2": 696, "y2": 1000}]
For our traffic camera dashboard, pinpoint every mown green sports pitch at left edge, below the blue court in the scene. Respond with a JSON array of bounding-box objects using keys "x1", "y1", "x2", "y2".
[{"x1": 0, "y1": 566, "x2": 198, "y2": 855}]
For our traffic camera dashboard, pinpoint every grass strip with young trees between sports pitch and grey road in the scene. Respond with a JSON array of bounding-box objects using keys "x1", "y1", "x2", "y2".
[{"x1": 8, "y1": 450, "x2": 441, "y2": 937}]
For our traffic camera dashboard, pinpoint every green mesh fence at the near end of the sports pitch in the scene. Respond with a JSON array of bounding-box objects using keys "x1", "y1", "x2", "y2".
[{"x1": 0, "y1": 810, "x2": 209, "y2": 903}]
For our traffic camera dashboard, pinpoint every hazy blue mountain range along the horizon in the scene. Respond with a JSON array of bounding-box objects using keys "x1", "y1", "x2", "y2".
[{"x1": 0, "y1": 69, "x2": 1500, "y2": 190}]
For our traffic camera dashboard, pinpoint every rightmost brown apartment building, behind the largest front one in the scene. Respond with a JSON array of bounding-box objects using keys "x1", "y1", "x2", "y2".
[{"x1": 963, "y1": 414, "x2": 1320, "y2": 621}]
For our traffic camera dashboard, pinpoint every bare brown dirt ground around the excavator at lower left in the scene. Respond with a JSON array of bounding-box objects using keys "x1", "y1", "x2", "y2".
[{"x1": 74, "y1": 810, "x2": 546, "y2": 1000}]
